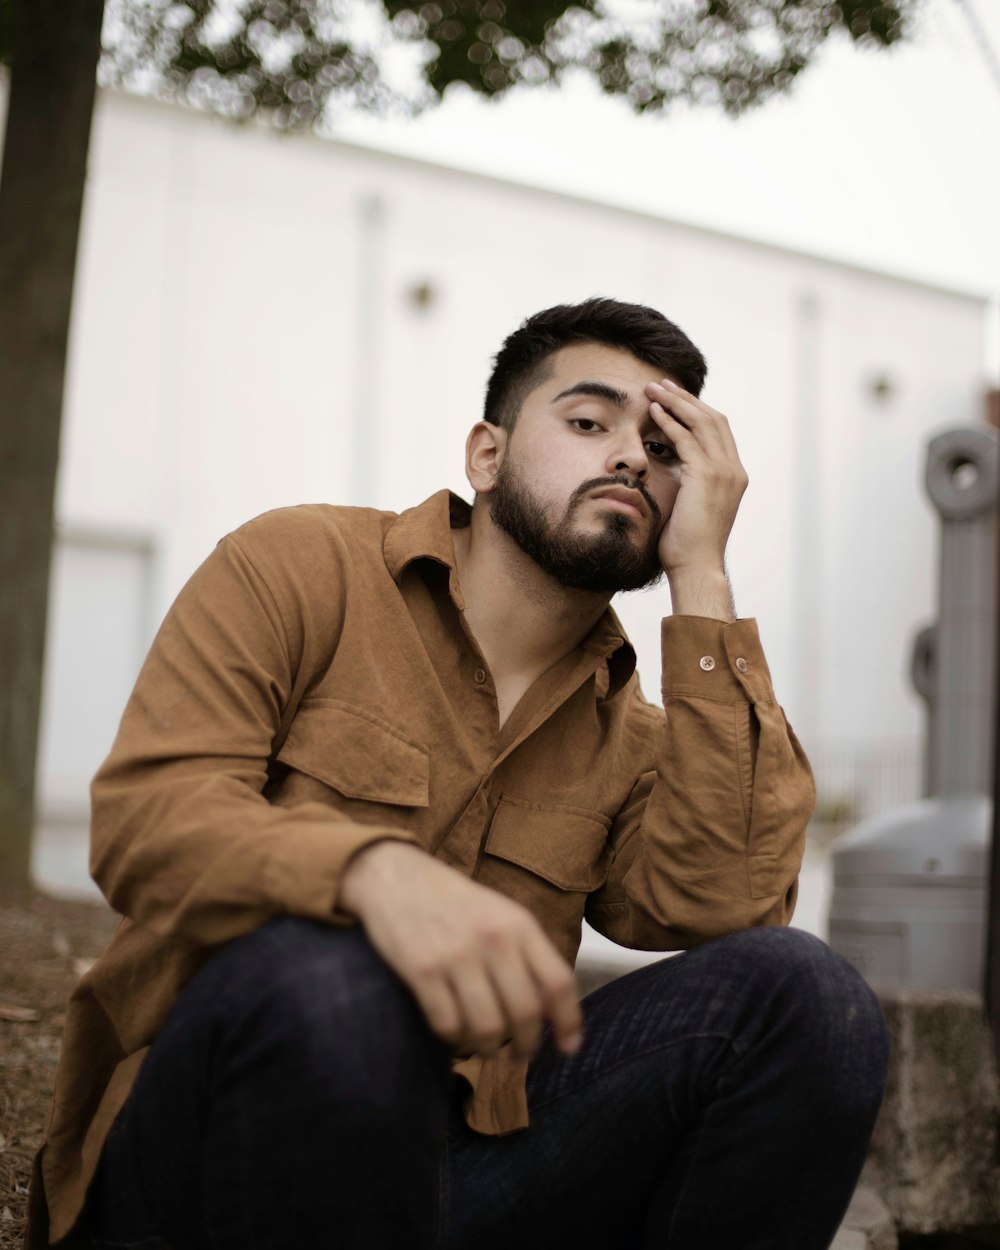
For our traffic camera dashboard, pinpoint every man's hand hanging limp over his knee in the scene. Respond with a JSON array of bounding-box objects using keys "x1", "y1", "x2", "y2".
[{"x1": 338, "y1": 841, "x2": 583, "y2": 1058}]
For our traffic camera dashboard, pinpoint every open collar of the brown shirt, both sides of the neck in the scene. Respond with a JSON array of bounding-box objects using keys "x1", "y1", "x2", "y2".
[{"x1": 384, "y1": 490, "x2": 635, "y2": 696}]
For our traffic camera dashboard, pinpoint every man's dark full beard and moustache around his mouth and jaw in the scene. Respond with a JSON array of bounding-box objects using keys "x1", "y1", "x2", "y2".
[{"x1": 489, "y1": 460, "x2": 664, "y2": 595}]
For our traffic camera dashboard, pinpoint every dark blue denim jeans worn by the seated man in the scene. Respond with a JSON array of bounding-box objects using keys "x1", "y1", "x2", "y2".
[{"x1": 88, "y1": 918, "x2": 888, "y2": 1250}]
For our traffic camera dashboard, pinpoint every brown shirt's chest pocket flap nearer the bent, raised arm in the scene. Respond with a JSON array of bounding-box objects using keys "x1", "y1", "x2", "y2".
[{"x1": 485, "y1": 796, "x2": 611, "y2": 893}]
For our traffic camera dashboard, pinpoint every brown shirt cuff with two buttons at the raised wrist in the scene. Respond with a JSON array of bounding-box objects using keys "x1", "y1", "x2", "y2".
[{"x1": 660, "y1": 616, "x2": 774, "y2": 703}]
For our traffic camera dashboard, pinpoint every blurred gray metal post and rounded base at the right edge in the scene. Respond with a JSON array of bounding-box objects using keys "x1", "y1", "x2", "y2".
[{"x1": 830, "y1": 428, "x2": 1000, "y2": 990}]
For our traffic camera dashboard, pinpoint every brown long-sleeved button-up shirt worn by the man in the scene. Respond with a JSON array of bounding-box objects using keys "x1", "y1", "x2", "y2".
[{"x1": 29, "y1": 491, "x2": 814, "y2": 1245}]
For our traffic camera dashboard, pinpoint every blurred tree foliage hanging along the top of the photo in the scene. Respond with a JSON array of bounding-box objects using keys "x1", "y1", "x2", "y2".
[{"x1": 0, "y1": 0, "x2": 919, "y2": 129}]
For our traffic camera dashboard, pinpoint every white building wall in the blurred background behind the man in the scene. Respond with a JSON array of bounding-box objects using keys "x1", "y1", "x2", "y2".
[{"x1": 19, "y1": 93, "x2": 984, "y2": 900}]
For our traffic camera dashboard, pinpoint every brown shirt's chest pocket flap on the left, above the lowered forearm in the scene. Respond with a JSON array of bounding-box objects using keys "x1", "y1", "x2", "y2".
[{"x1": 278, "y1": 699, "x2": 430, "y2": 808}]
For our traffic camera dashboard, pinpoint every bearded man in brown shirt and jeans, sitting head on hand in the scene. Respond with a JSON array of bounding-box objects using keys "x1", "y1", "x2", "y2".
[{"x1": 27, "y1": 300, "x2": 885, "y2": 1250}]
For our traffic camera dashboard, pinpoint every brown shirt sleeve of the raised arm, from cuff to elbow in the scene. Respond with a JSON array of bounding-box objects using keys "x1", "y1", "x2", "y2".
[{"x1": 588, "y1": 616, "x2": 815, "y2": 949}]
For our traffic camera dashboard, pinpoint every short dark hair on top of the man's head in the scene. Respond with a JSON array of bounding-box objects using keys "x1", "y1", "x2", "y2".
[{"x1": 483, "y1": 298, "x2": 708, "y2": 429}]
